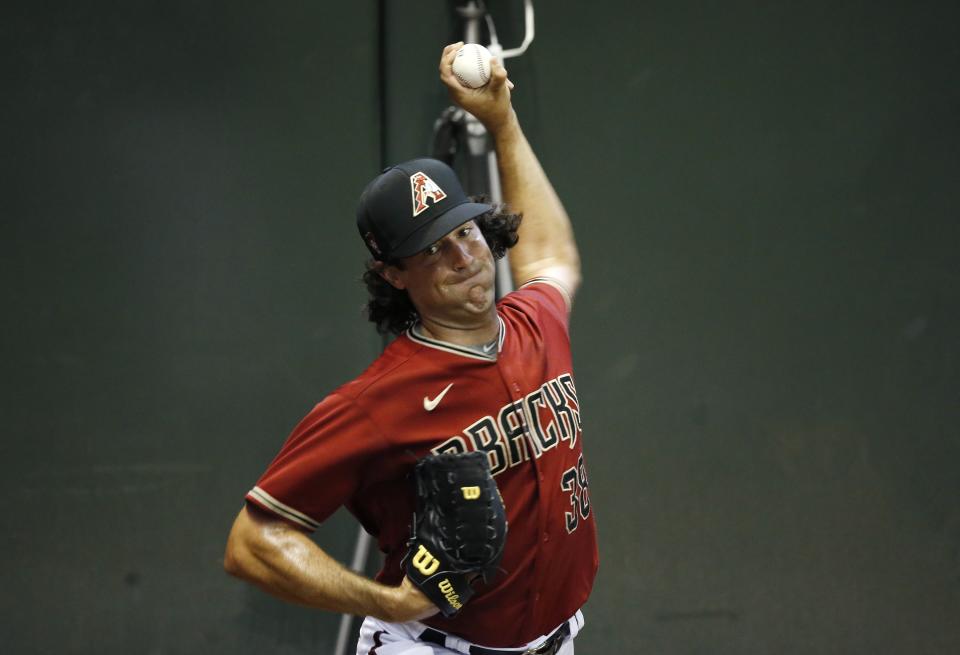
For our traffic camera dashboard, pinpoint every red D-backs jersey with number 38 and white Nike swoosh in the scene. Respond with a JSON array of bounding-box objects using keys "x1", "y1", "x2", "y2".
[{"x1": 247, "y1": 279, "x2": 598, "y2": 648}]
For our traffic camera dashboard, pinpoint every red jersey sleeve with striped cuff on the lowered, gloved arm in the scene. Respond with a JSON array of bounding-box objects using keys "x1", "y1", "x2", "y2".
[{"x1": 246, "y1": 393, "x2": 385, "y2": 530}]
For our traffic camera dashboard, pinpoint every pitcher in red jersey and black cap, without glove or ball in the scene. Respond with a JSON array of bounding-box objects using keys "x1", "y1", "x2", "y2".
[{"x1": 225, "y1": 43, "x2": 598, "y2": 655}]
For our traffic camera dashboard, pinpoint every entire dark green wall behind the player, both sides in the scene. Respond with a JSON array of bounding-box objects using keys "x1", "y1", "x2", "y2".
[{"x1": 0, "y1": 0, "x2": 960, "y2": 655}]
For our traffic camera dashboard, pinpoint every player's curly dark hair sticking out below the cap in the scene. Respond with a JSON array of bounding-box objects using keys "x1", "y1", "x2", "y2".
[{"x1": 363, "y1": 197, "x2": 522, "y2": 334}]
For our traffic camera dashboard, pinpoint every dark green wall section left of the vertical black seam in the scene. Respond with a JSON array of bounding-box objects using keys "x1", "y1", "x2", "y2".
[{"x1": 0, "y1": 1, "x2": 379, "y2": 654}]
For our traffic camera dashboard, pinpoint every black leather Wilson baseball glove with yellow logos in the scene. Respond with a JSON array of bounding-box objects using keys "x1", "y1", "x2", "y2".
[{"x1": 405, "y1": 452, "x2": 507, "y2": 617}]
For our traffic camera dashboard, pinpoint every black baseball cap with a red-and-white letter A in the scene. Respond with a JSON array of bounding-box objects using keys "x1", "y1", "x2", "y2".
[{"x1": 357, "y1": 159, "x2": 492, "y2": 261}]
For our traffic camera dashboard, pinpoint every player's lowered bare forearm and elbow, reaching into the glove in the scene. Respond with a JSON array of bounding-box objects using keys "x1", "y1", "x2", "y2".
[{"x1": 224, "y1": 506, "x2": 438, "y2": 622}]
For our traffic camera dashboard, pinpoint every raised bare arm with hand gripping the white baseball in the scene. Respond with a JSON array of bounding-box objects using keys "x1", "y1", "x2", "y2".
[{"x1": 440, "y1": 43, "x2": 581, "y2": 300}]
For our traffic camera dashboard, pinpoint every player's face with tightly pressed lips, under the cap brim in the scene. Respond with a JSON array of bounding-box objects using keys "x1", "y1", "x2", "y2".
[{"x1": 387, "y1": 221, "x2": 494, "y2": 324}]
